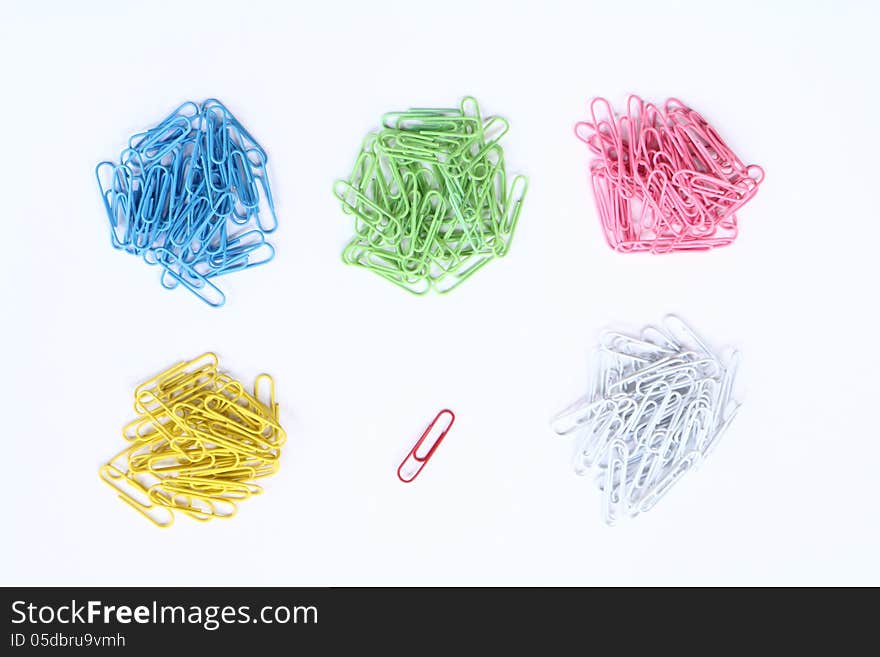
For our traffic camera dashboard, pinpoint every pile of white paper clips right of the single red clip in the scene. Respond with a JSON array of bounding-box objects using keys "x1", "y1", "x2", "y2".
[{"x1": 553, "y1": 315, "x2": 740, "y2": 525}]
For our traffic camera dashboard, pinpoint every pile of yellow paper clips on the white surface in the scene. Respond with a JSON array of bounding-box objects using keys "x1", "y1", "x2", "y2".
[{"x1": 99, "y1": 353, "x2": 286, "y2": 527}]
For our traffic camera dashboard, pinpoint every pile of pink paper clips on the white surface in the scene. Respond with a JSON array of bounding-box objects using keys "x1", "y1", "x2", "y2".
[{"x1": 575, "y1": 96, "x2": 764, "y2": 253}]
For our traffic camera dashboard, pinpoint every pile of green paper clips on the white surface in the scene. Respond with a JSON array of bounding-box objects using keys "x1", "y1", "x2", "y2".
[{"x1": 334, "y1": 97, "x2": 528, "y2": 294}]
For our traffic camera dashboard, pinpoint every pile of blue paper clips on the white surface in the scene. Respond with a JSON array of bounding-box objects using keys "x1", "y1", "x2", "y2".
[{"x1": 95, "y1": 99, "x2": 278, "y2": 307}]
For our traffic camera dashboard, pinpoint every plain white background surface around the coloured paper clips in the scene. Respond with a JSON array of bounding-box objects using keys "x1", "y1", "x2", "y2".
[{"x1": 0, "y1": 0, "x2": 880, "y2": 585}]
